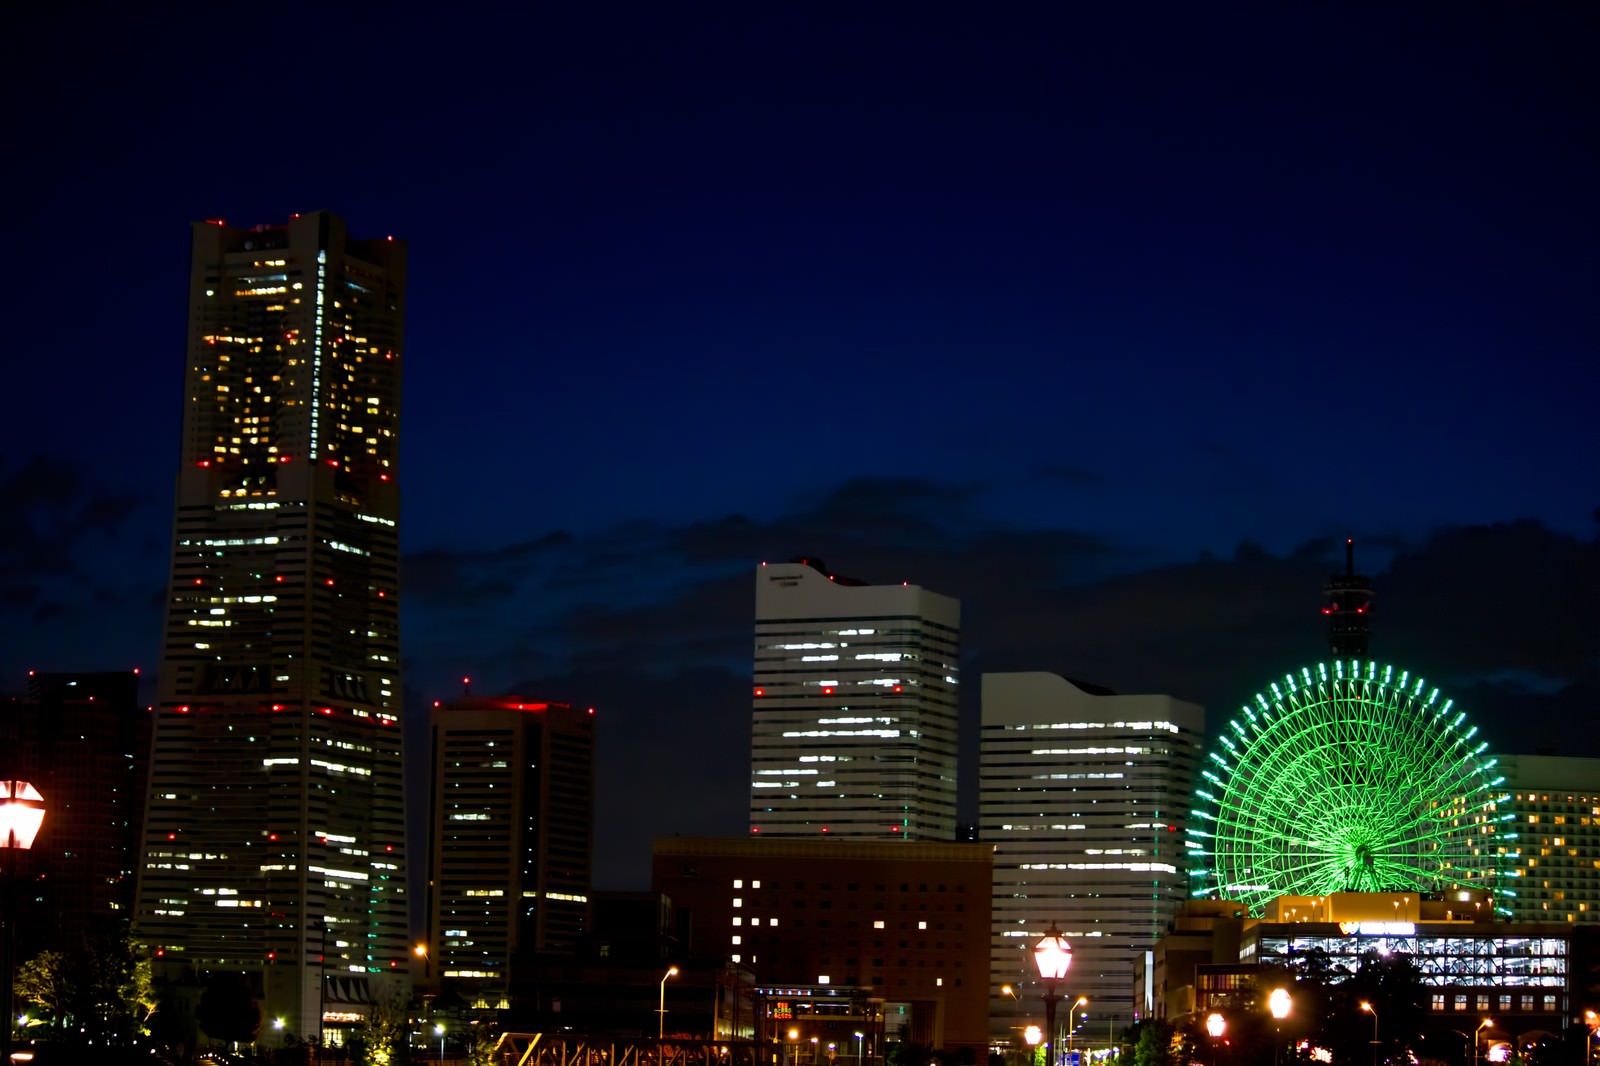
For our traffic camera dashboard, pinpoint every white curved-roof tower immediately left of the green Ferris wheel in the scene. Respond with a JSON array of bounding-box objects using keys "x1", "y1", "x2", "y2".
[{"x1": 978, "y1": 672, "x2": 1205, "y2": 1047}]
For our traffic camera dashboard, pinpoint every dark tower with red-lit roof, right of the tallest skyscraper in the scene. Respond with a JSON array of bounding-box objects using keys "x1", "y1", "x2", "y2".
[{"x1": 427, "y1": 696, "x2": 595, "y2": 1008}]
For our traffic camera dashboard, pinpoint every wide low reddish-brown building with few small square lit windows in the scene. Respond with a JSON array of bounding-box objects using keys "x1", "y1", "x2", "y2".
[{"x1": 651, "y1": 836, "x2": 994, "y2": 1061}]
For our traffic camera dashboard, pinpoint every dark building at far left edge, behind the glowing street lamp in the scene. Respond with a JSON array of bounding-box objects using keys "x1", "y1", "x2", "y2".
[{"x1": 0, "y1": 671, "x2": 150, "y2": 957}]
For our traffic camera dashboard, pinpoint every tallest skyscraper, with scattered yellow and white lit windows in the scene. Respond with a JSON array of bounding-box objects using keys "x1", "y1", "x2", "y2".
[{"x1": 136, "y1": 211, "x2": 410, "y2": 1042}]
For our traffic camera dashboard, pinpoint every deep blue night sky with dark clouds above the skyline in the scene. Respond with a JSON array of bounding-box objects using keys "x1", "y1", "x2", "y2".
[{"x1": 0, "y1": 3, "x2": 1600, "y2": 888}]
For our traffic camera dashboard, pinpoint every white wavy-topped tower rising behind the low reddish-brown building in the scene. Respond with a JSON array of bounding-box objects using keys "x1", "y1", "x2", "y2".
[{"x1": 750, "y1": 559, "x2": 962, "y2": 840}]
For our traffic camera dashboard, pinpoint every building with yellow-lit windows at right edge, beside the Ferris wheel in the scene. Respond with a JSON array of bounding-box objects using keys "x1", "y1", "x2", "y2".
[{"x1": 1498, "y1": 755, "x2": 1600, "y2": 925}]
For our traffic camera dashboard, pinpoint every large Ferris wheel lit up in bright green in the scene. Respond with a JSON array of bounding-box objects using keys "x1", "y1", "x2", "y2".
[{"x1": 1186, "y1": 661, "x2": 1515, "y2": 914}]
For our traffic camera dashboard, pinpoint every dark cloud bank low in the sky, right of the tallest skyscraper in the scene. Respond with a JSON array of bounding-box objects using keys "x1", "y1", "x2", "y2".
[{"x1": 387, "y1": 479, "x2": 1600, "y2": 885}]
